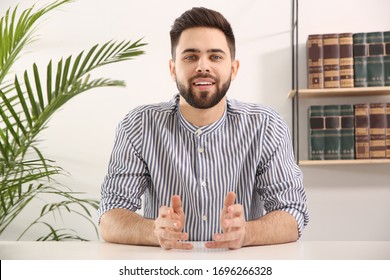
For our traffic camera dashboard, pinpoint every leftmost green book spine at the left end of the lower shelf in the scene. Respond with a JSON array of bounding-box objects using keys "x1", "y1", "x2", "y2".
[{"x1": 308, "y1": 105, "x2": 325, "y2": 160}]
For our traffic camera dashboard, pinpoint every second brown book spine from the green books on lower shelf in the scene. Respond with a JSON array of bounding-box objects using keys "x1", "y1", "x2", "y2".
[{"x1": 369, "y1": 103, "x2": 386, "y2": 159}]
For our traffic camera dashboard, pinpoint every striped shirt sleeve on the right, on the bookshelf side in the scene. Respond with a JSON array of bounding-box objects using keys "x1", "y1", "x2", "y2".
[{"x1": 257, "y1": 111, "x2": 309, "y2": 236}]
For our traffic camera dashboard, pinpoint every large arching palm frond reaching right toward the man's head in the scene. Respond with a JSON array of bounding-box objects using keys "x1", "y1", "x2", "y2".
[{"x1": 0, "y1": 38, "x2": 145, "y2": 165}]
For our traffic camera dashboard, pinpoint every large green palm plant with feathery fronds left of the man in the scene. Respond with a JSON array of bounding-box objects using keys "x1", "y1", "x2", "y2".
[{"x1": 0, "y1": 0, "x2": 145, "y2": 241}]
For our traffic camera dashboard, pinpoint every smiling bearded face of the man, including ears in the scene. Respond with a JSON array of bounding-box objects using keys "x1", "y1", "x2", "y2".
[{"x1": 170, "y1": 27, "x2": 238, "y2": 109}]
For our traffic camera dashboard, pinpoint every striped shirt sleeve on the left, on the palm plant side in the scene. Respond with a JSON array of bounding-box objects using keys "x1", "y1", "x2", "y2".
[{"x1": 98, "y1": 111, "x2": 150, "y2": 220}]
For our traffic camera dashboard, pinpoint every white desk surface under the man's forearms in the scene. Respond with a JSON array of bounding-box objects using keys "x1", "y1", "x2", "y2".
[{"x1": 0, "y1": 241, "x2": 390, "y2": 260}]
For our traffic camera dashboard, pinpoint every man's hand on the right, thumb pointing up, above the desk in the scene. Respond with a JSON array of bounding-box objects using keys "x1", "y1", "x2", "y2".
[{"x1": 206, "y1": 192, "x2": 245, "y2": 249}]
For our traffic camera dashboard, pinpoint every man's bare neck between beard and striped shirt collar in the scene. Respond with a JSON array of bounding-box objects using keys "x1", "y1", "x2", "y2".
[{"x1": 180, "y1": 97, "x2": 226, "y2": 127}]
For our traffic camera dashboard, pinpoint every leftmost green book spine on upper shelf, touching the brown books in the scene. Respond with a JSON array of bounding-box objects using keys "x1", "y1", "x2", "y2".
[{"x1": 352, "y1": 33, "x2": 368, "y2": 87}]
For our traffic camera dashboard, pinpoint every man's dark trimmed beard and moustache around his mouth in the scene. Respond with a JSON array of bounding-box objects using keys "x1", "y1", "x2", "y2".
[{"x1": 176, "y1": 74, "x2": 231, "y2": 109}]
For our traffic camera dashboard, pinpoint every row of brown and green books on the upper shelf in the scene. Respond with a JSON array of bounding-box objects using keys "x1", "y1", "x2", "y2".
[{"x1": 307, "y1": 31, "x2": 390, "y2": 89}]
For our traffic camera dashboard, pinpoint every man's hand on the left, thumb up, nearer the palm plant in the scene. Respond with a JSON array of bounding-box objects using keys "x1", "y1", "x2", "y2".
[{"x1": 154, "y1": 195, "x2": 192, "y2": 250}]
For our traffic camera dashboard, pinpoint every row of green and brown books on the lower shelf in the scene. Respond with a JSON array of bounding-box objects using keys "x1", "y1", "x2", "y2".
[{"x1": 308, "y1": 103, "x2": 390, "y2": 160}]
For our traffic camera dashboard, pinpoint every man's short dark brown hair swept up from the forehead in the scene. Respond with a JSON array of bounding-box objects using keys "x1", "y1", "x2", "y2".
[{"x1": 170, "y1": 7, "x2": 236, "y2": 59}]
